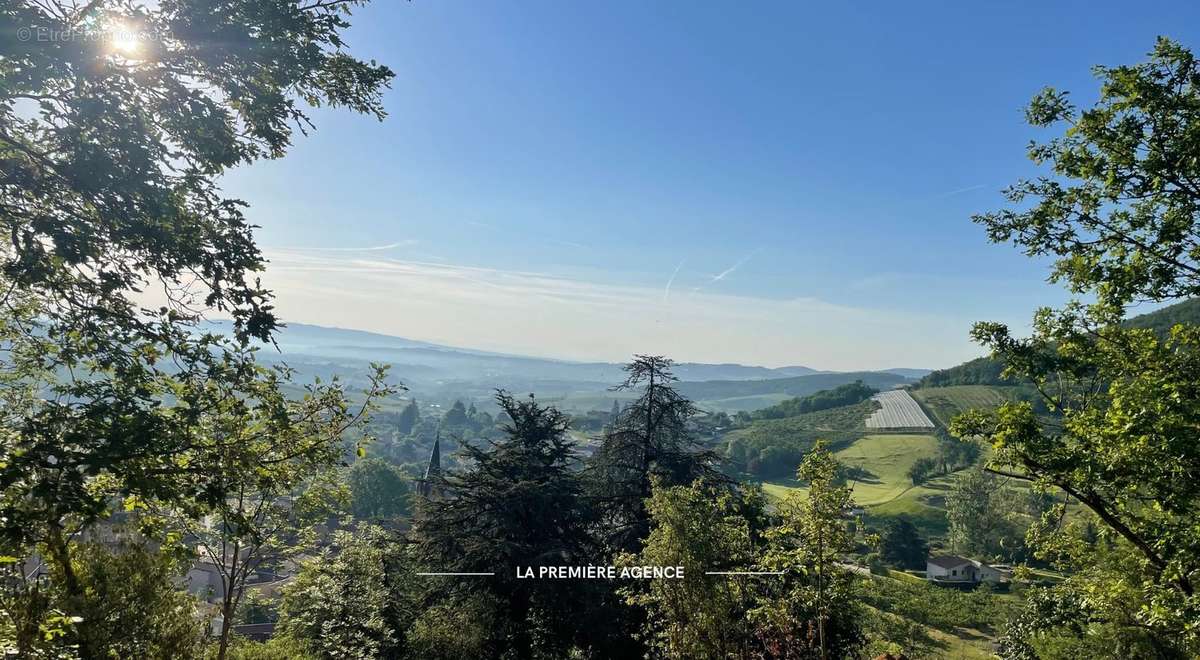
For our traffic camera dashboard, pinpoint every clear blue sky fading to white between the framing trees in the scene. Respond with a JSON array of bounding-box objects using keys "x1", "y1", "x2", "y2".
[{"x1": 218, "y1": 0, "x2": 1200, "y2": 370}]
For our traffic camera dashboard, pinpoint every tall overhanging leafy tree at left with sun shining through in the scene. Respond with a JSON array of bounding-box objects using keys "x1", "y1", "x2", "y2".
[{"x1": 0, "y1": 0, "x2": 391, "y2": 656}]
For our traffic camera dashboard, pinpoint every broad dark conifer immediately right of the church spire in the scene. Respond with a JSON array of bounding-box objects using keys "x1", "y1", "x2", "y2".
[{"x1": 414, "y1": 391, "x2": 593, "y2": 658}]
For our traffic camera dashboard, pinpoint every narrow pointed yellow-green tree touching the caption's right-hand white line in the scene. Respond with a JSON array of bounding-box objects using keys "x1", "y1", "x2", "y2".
[{"x1": 749, "y1": 442, "x2": 866, "y2": 660}]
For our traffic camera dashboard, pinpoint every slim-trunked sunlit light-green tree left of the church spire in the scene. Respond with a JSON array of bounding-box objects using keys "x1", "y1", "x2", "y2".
[{"x1": 159, "y1": 365, "x2": 395, "y2": 660}]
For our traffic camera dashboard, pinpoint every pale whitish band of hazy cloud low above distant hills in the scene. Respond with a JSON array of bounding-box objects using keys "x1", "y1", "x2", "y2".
[{"x1": 248, "y1": 251, "x2": 977, "y2": 370}]
